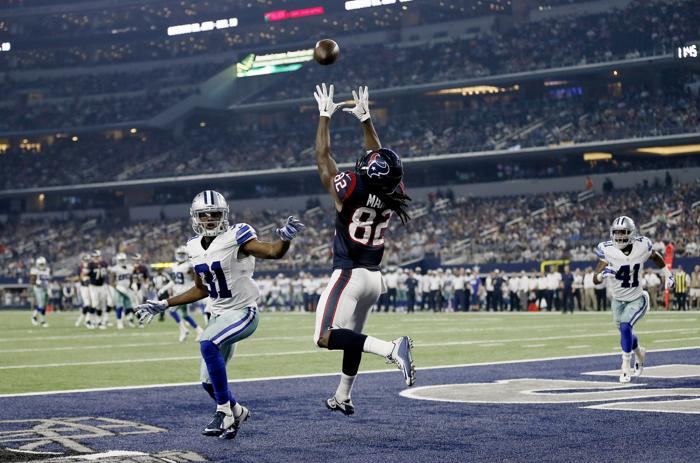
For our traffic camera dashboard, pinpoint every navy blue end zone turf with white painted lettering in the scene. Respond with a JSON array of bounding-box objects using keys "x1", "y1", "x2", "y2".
[{"x1": 0, "y1": 349, "x2": 700, "y2": 463}]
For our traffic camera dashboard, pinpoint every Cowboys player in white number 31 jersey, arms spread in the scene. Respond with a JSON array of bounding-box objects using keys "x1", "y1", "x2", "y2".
[{"x1": 136, "y1": 190, "x2": 304, "y2": 439}]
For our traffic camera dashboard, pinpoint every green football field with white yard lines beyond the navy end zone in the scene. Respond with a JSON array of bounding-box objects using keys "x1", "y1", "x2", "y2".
[{"x1": 0, "y1": 311, "x2": 700, "y2": 394}]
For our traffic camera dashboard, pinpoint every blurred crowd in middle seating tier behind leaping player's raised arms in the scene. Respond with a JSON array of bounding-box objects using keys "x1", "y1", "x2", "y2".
[{"x1": 0, "y1": 73, "x2": 700, "y2": 189}]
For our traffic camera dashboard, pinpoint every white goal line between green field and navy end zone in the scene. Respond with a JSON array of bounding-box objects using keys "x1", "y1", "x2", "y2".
[{"x1": 0, "y1": 346, "x2": 700, "y2": 399}]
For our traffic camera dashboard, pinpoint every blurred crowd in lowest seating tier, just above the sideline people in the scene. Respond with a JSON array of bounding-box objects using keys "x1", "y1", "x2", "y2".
[{"x1": 0, "y1": 177, "x2": 700, "y2": 281}]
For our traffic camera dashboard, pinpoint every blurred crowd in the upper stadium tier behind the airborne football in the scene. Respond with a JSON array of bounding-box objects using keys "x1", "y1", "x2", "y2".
[{"x1": 0, "y1": 1, "x2": 700, "y2": 134}]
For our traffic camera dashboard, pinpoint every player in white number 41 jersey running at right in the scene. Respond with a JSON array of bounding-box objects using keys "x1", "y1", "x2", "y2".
[{"x1": 593, "y1": 216, "x2": 674, "y2": 383}]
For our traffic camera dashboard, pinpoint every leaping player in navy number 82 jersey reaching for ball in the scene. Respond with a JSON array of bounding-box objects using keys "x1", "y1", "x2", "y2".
[{"x1": 314, "y1": 84, "x2": 415, "y2": 415}]
